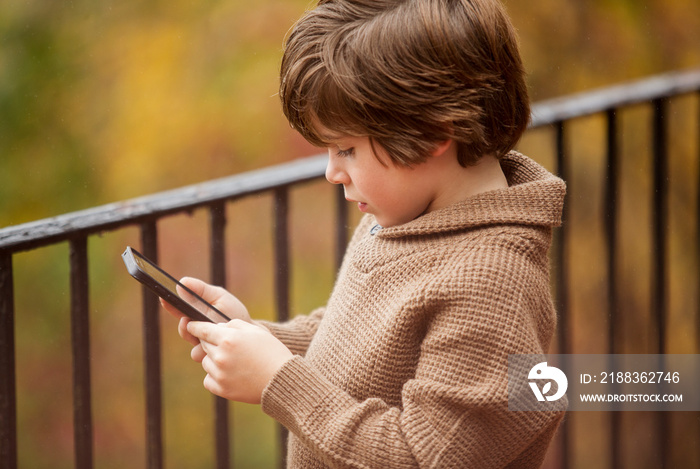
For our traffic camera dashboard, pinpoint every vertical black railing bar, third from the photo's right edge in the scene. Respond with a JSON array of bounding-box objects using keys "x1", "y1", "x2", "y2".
[{"x1": 604, "y1": 109, "x2": 622, "y2": 467}]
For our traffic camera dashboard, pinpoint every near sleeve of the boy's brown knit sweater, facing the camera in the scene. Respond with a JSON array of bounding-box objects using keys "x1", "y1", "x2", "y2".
[{"x1": 262, "y1": 232, "x2": 563, "y2": 469}]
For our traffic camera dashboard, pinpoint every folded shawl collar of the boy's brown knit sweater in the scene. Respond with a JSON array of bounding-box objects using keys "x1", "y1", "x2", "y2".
[{"x1": 376, "y1": 151, "x2": 566, "y2": 238}]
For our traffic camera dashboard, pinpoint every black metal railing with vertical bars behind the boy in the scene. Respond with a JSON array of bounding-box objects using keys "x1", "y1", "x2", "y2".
[{"x1": 0, "y1": 70, "x2": 700, "y2": 469}]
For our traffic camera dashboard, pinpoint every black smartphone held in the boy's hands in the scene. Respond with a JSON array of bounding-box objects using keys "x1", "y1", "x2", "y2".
[{"x1": 122, "y1": 246, "x2": 231, "y2": 323}]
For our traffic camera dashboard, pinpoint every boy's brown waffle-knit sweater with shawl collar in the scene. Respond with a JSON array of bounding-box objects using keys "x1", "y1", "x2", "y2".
[{"x1": 262, "y1": 152, "x2": 565, "y2": 469}]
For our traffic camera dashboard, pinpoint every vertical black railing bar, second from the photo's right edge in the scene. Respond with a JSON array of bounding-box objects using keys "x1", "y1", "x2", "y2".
[{"x1": 651, "y1": 98, "x2": 670, "y2": 467}]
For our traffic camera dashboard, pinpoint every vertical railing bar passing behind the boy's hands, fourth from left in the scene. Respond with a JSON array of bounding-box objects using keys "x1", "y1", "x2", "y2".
[{"x1": 209, "y1": 202, "x2": 231, "y2": 469}]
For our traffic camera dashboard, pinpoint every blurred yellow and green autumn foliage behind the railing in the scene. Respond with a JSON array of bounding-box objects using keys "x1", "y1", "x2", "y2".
[{"x1": 0, "y1": 0, "x2": 700, "y2": 468}]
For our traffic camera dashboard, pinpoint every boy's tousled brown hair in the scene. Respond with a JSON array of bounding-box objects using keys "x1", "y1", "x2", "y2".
[{"x1": 280, "y1": 0, "x2": 530, "y2": 166}]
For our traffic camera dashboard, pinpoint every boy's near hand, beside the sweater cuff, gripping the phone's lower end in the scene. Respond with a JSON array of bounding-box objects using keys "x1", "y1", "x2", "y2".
[{"x1": 186, "y1": 319, "x2": 293, "y2": 404}]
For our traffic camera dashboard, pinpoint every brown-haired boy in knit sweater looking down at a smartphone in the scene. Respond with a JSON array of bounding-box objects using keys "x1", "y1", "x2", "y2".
[{"x1": 166, "y1": 0, "x2": 565, "y2": 468}]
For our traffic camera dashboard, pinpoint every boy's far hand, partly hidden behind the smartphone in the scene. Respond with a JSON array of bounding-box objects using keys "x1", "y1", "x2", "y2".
[{"x1": 160, "y1": 277, "x2": 252, "y2": 345}]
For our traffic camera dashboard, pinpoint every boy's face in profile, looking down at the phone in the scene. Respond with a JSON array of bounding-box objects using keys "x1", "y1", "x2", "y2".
[{"x1": 326, "y1": 133, "x2": 437, "y2": 228}]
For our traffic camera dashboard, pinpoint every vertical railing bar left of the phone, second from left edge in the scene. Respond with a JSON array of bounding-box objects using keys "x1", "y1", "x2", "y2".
[{"x1": 70, "y1": 237, "x2": 93, "y2": 469}]
